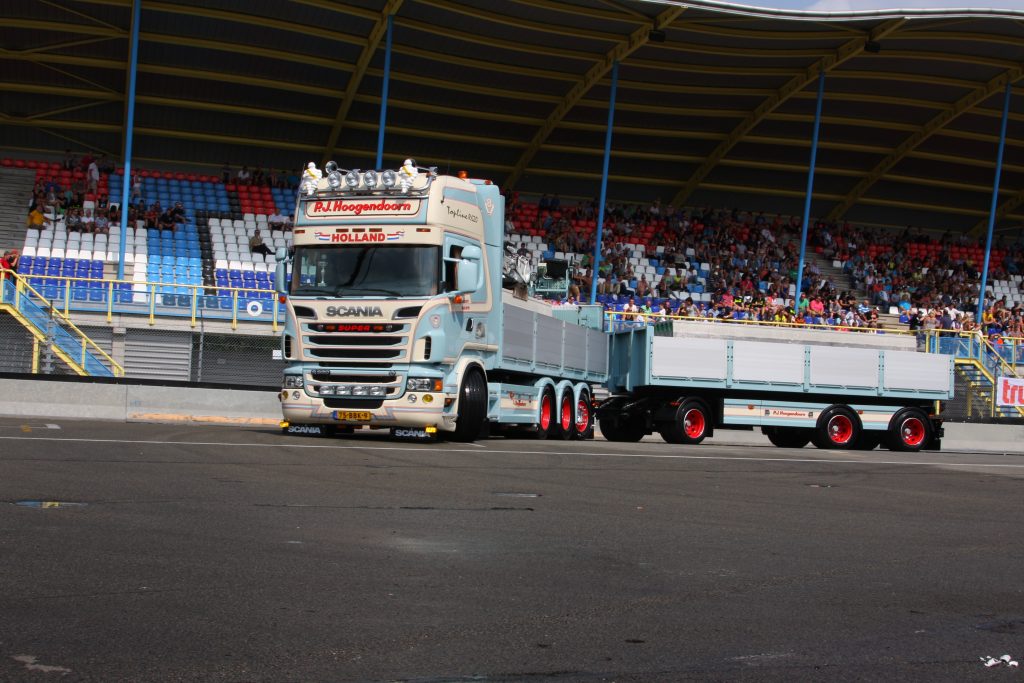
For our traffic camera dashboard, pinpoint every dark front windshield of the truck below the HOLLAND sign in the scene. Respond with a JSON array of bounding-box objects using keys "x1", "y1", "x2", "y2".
[{"x1": 292, "y1": 245, "x2": 440, "y2": 297}]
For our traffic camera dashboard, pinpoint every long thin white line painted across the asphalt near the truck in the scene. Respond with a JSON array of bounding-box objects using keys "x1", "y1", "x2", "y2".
[{"x1": 0, "y1": 436, "x2": 1024, "y2": 469}]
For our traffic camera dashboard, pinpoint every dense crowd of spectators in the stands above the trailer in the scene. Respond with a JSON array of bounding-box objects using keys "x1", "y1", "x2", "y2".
[{"x1": 508, "y1": 195, "x2": 1024, "y2": 335}]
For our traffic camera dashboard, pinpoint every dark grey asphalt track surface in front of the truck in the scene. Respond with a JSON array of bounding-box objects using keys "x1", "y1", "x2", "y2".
[{"x1": 0, "y1": 419, "x2": 1024, "y2": 683}]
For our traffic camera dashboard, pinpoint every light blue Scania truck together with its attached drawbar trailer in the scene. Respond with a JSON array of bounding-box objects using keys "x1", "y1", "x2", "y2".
[{"x1": 275, "y1": 163, "x2": 953, "y2": 451}]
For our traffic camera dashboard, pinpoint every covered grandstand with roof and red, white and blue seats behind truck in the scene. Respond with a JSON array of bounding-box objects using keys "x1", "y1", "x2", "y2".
[{"x1": 0, "y1": 0, "x2": 1024, "y2": 419}]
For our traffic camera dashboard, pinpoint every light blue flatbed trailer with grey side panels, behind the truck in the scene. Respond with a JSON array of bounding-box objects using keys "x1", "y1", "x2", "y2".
[{"x1": 596, "y1": 327, "x2": 953, "y2": 451}]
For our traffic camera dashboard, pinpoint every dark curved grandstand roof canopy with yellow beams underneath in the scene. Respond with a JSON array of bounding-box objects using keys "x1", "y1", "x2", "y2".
[{"x1": 0, "y1": 0, "x2": 1024, "y2": 235}]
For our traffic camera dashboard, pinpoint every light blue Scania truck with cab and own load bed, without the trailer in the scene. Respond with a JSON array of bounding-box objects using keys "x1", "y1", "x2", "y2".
[{"x1": 276, "y1": 163, "x2": 608, "y2": 440}]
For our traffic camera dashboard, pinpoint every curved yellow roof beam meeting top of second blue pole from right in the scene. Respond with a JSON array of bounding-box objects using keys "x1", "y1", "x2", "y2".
[{"x1": 672, "y1": 18, "x2": 906, "y2": 206}]
